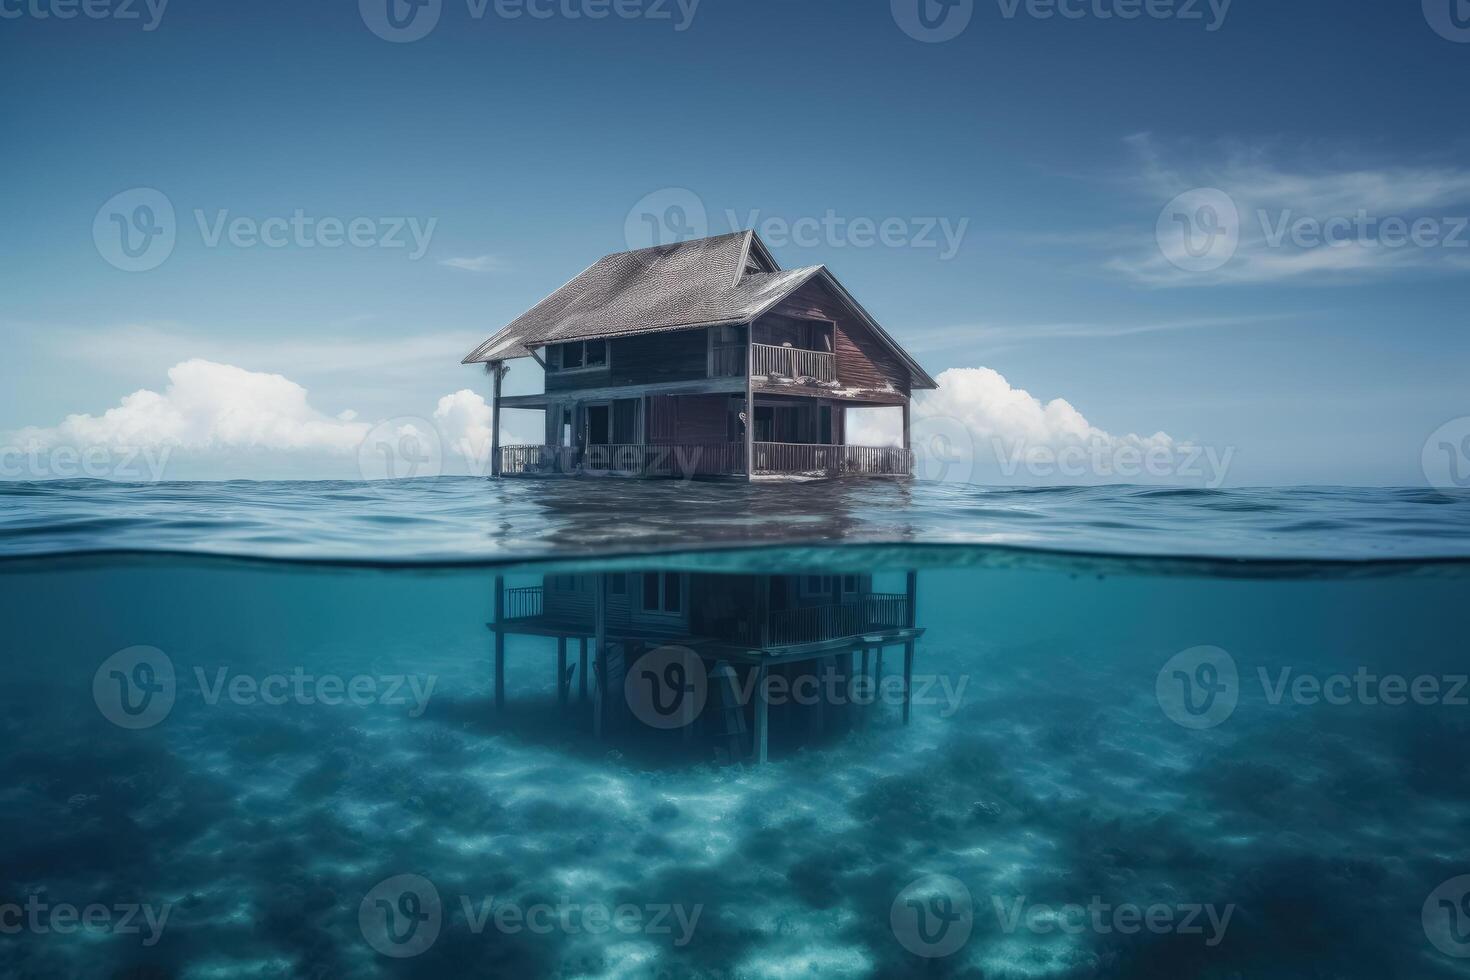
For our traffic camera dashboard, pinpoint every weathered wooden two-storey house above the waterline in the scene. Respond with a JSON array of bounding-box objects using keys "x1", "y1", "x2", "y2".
[{"x1": 463, "y1": 231, "x2": 936, "y2": 479}]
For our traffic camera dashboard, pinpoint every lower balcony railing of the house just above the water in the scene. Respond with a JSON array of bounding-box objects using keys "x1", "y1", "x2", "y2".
[{"x1": 500, "y1": 442, "x2": 913, "y2": 478}]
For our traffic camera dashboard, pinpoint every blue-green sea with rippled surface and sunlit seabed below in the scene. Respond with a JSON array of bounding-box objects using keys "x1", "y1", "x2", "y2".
[{"x1": 0, "y1": 479, "x2": 1470, "y2": 980}]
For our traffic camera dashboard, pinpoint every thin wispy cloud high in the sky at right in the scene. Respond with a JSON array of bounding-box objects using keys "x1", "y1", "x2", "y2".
[{"x1": 1104, "y1": 134, "x2": 1470, "y2": 287}]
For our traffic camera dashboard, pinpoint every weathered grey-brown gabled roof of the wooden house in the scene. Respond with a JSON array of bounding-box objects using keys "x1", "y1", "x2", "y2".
[{"x1": 463, "y1": 231, "x2": 938, "y2": 388}]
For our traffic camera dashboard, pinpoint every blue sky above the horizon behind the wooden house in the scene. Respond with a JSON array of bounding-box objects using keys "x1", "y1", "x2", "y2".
[{"x1": 0, "y1": 0, "x2": 1470, "y2": 485}]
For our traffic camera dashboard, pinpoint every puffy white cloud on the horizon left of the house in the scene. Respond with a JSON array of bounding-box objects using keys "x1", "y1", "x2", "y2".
[{"x1": 13, "y1": 359, "x2": 369, "y2": 454}]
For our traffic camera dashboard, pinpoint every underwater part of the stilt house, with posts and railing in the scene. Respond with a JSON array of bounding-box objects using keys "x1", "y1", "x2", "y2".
[{"x1": 487, "y1": 569, "x2": 925, "y2": 763}]
